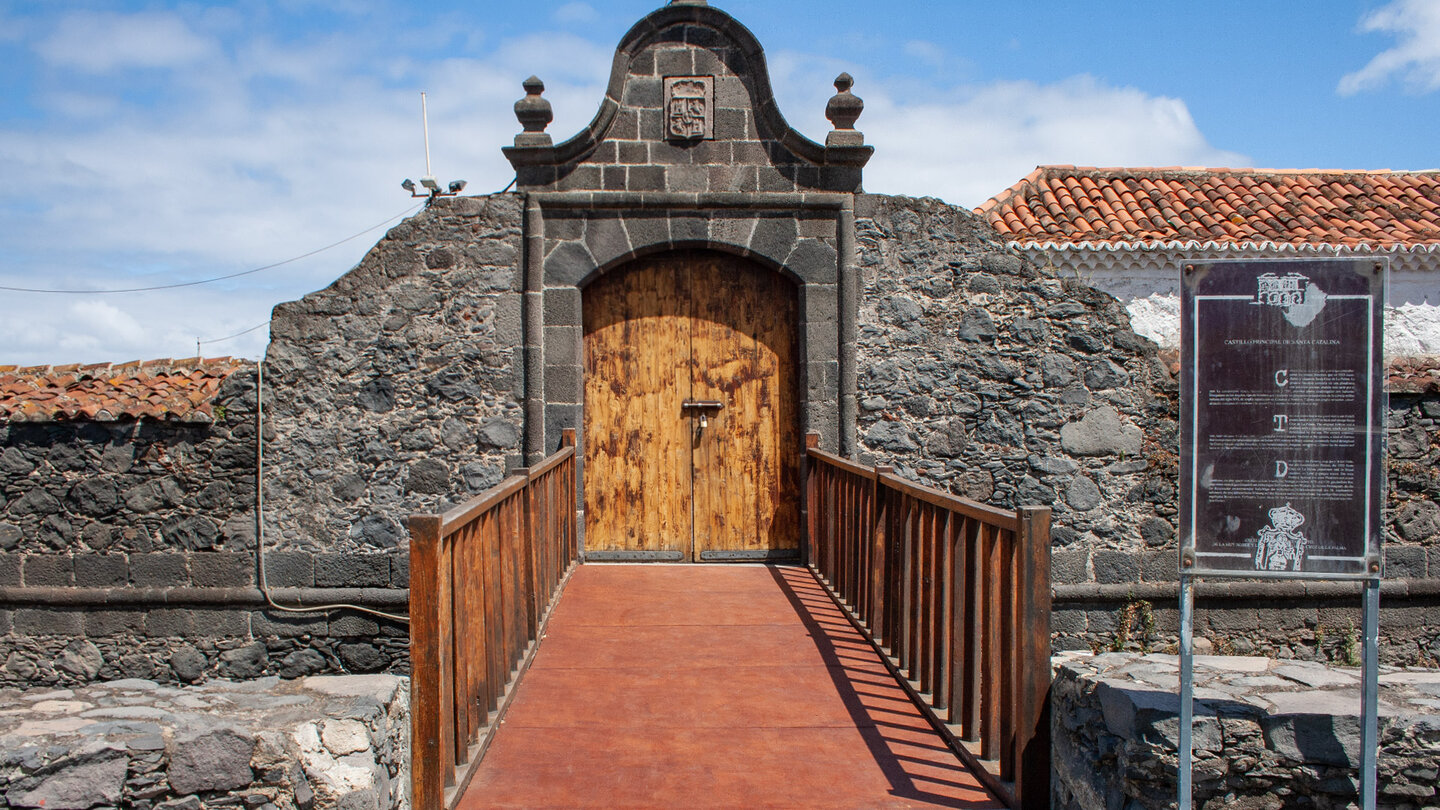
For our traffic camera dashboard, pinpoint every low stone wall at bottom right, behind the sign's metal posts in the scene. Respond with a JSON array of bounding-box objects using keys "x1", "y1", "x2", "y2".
[{"x1": 1051, "y1": 653, "x2": 1440, "y2": 810}]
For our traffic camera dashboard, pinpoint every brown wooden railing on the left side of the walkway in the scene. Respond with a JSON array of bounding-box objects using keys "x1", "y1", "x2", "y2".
[{"x1": 410, "y1": 431, "x2": 577, "y2": 810}]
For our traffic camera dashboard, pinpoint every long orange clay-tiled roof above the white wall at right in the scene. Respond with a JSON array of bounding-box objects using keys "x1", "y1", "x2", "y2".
[{"x1": 975, "y1": 166, "x2": 1440, "y2": 249}]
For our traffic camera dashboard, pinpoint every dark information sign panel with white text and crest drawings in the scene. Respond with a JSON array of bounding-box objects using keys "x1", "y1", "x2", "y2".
[{"x1": 1181, "y1": 259, "x2": 1385, "y2": 578}]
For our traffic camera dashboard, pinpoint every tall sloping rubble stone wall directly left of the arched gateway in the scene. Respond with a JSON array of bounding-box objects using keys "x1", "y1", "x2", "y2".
[{"x1": 265, "y1": 195, "x2": 523, "y2": 553}]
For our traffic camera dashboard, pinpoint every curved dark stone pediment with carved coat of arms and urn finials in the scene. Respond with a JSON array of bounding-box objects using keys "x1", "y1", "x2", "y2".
[{"x1": 504, "y1": 0, "x2": 874, "y2": 193}]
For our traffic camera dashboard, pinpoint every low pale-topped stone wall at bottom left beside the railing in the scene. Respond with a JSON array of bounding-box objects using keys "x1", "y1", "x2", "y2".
[{"x1": 0, "y1": 675, "x2": 410, "y2": 810}]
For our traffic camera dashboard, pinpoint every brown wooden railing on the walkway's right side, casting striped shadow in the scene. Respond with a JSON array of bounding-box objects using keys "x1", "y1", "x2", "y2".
[{"x1": 806, "y1": 435, "x2": 1051, "y2": 810}]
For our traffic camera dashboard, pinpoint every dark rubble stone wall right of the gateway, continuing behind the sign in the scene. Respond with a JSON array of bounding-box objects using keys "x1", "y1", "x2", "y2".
[{"x1": 857, "y1": 195, "x2": 1440, "y2": 664}]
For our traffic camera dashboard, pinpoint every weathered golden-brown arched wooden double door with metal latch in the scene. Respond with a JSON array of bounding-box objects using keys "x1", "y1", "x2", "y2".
[{"x1": 583, "y1": 251, "x2": 802, "y2": 562}]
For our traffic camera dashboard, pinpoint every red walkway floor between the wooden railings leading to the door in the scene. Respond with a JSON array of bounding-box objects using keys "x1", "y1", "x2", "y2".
[{"x1": 459, "y1": 565, "x2": 1001, "y2": 810}]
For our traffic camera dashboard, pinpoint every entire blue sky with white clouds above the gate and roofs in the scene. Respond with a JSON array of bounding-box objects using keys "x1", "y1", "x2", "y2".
[{"x1": 0, "y1": 0, "x2": 1440, "y2": 365}]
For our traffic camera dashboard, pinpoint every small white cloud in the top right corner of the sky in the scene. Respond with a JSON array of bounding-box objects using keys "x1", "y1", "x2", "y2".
[{"x1": 1336, "y1": 0, "x2": 1440, "y2": 95}]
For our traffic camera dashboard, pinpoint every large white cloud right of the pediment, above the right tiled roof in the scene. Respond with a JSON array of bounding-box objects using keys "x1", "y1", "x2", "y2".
[{"x1": 772, "y1": 53, "x2": 1248, "y2": 206}]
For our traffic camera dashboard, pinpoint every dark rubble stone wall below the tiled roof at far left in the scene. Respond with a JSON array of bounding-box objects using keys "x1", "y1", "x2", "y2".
[{"x1": 0, "y1": 368, "x2": 255, "y2": 559}]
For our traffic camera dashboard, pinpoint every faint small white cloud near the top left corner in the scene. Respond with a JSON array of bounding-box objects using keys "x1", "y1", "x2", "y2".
[{"x1": 36, "y1": 12, "x2": 215, "y2": 74}]
